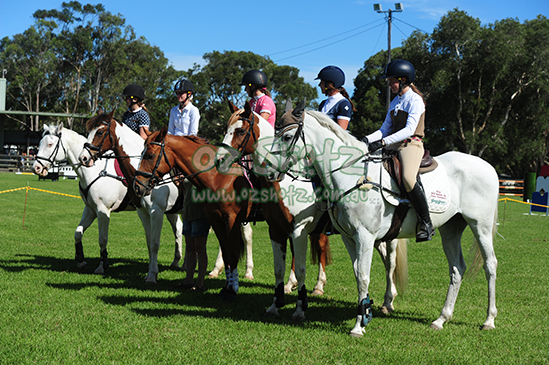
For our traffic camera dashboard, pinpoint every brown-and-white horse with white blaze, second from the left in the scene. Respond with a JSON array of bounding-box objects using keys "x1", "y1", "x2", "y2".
[{"x1": 79, "y1": 113, "x2": 253, "y2": 283}]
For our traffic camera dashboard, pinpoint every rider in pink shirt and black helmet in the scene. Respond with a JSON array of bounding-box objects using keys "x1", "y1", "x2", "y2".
[{"x1": 239, "y1": 70, "x2": 276, "y2": 128}]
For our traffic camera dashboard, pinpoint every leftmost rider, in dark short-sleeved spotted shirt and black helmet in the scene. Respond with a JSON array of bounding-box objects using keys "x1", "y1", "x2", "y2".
[{"x1": 122, "y1": 84, "x2": 151, "y2": 139}]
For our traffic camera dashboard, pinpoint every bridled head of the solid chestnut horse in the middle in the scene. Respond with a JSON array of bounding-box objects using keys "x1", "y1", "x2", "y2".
[{"x1": 133, "y1": 127, "x2": 173, "y2": 197}]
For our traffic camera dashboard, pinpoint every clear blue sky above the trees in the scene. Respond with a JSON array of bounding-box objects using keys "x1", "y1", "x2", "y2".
[{"x1": 0, "y1": 0, "x2": 549, "y2": 94}]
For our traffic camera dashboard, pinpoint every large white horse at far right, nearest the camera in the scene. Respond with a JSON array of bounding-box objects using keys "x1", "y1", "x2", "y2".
[{"x1": 272, "y1": 103, "x2": 499, "y2": 336}]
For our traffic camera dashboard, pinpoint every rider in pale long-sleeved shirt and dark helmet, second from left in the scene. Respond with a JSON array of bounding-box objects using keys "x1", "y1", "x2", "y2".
[{"x1": 168, "y1": 79, "x2": 200, "y2": 136}]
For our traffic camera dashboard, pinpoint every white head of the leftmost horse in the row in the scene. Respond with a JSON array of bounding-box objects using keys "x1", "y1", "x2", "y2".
[{"x1": 32, "y1": 124, "x2": 67, "y2": 176}]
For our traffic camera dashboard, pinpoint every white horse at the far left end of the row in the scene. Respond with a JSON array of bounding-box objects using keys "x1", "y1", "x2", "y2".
[{"x1": 33, "y1": 124, "x2": 183, "y2": 274}]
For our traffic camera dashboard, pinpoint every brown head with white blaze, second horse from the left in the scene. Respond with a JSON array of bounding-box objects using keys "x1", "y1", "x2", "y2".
[{"x1": 79, "y1": 110, "x2": 121, "y2": 167}]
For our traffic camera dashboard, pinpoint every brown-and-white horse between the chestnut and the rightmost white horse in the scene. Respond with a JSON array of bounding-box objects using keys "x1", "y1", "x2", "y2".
[{"x1": 219, "y1": 102, "x2": 407, "y2": 320}]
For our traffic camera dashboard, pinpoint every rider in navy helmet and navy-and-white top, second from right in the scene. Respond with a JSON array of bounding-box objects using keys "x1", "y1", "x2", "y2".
[{"x1": 315, "y1": 66, "x2": 355, "y2": 129}]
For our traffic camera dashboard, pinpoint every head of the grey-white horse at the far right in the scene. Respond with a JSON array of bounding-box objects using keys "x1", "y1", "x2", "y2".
[{"x1": 268, "y1": 100, "x2": 305, "y2": 181}]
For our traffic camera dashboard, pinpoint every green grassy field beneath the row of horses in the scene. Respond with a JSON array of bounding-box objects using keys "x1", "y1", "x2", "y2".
[{"x1": 0, "y1": 173, "x2": 549, "y2": 365}]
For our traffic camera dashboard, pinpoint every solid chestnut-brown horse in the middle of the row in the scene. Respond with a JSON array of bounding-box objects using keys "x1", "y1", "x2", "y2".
[{"x1": 134, "y1": 127, "x2": 252, "y2": 300}]
